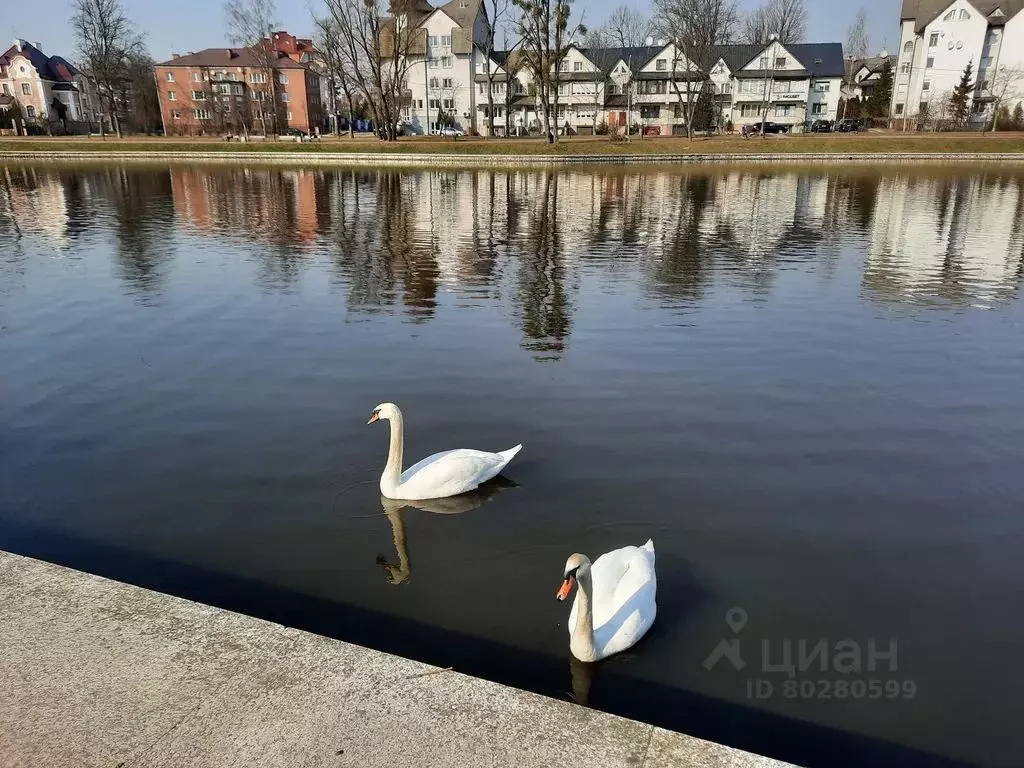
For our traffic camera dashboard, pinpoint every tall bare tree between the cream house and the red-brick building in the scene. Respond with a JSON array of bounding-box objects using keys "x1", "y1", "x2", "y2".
[{"x1": 72, "y1": 0, "x2": 144, "y2": 138}]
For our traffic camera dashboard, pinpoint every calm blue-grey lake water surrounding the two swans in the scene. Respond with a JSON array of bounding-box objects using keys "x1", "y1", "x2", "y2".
[{"x1": 0, "y1": 164, "x2": 1024, "y2": 766}]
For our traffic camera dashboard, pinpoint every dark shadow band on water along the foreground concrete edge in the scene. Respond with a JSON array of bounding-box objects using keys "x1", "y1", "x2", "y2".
[{"x1": 0, "y1": 523, "x2": 964, "y2": 768}]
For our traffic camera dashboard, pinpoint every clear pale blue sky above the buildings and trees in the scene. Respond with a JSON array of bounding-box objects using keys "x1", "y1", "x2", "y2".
[{"x1": 8, "y1": 0, "x2": 900, "y2": 61}]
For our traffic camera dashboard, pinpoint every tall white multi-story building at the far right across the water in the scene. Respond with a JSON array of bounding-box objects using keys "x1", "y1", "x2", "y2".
[{"x1": 892, "y1": 0, "x2": 1024, "y2": 121}]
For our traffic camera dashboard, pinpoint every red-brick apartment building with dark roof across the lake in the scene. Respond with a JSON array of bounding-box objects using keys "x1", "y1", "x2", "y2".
[{"x1": 155, "y1": 37, "x2": 324, "y2": 136}]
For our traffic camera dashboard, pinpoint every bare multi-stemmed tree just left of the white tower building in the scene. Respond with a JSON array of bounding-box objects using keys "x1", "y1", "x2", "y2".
[{"x1": 325, "y1": 0, "x2": 415, "y2": 141}]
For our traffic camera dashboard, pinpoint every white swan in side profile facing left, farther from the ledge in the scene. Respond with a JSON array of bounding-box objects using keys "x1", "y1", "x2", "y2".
[{"x1": 367, "y1": 402, "x2": 522, "y2": 500}]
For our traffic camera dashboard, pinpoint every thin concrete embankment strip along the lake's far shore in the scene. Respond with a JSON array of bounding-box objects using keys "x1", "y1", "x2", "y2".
[{"x1": 0, "y1": 150, "x2": 1024, "y2": 168}]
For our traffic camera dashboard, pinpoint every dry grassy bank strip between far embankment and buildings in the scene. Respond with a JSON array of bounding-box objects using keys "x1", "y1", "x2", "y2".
[{"x1": 0, "y1": 131, "x2": 1024, "y2": 157}]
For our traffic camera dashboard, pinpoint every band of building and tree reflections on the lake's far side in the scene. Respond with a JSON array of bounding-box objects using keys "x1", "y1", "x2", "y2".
[{"x1": 0, "y1": 166, "x2": 1024, "y2": 350}]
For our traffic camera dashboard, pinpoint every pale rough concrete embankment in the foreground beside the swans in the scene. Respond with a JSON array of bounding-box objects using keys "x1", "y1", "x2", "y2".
[{"x1": 0, "y1": 552, "x2": 784, "y2": 768}]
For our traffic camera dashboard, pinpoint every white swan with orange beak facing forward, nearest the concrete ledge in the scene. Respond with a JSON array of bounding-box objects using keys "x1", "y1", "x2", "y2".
[{"x1": 556, "y1": 539, "x2": 657, "y2": 662}]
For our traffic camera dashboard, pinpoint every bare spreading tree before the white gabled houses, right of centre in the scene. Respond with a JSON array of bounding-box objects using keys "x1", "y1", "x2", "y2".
[{"x1": 654, "y1": 0, "x2": 739, "y2": 139}]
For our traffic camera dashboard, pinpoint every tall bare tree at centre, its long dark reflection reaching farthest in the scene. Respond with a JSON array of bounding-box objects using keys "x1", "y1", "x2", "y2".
[{"x1": 512, "y1": 0, "x2": 587, "y2": 142}]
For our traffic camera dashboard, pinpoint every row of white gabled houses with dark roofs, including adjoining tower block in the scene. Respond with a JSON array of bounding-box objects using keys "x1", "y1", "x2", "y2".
[{"x1": 392, "y1": 0, "x2": 844, "y2": 135}]
